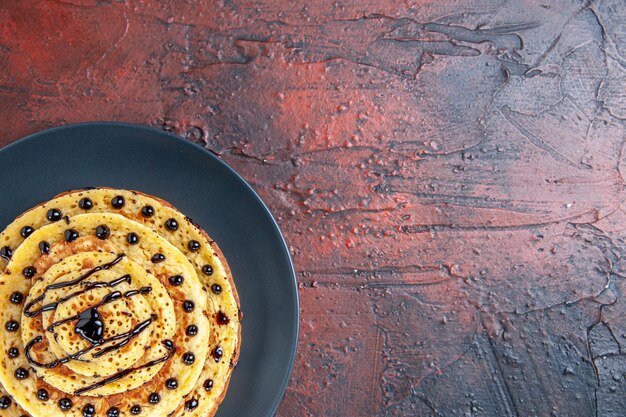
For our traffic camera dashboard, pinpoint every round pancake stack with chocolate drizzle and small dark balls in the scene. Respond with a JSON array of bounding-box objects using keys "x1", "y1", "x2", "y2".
[{"x1": 0, "y1": 188, "x2": 241, "y2": 417}]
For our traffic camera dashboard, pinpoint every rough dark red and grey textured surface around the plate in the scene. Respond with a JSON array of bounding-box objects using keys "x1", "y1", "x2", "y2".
[{"x1": 0, "y1": 0, "x2": 626, "y2": 417}]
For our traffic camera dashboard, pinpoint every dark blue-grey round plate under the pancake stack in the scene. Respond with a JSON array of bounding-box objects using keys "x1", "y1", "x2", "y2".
[{"x1": 0, "y1": 123, "x2": 299, "y2": 417}]
